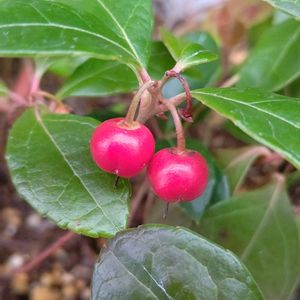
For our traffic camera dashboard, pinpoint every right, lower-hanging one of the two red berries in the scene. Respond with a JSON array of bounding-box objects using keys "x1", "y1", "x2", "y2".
[{"x1": 147, "y1": 148, "x2": 208, "y2": 202}]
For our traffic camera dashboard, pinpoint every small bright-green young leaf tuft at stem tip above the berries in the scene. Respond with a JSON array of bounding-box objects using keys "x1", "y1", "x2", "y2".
[{"x1": 160, "y1": 29, "x2": 217, "y2": 72}]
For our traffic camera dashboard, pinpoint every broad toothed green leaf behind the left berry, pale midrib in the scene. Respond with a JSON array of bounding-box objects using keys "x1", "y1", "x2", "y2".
[{"x1": 7, "y1": 110, "x2": 130, "y2": 237}]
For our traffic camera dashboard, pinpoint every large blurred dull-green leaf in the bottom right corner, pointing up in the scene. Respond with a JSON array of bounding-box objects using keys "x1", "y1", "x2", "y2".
[{"x1": 200, "y1": 177, "x2": 300, "y2": 300}]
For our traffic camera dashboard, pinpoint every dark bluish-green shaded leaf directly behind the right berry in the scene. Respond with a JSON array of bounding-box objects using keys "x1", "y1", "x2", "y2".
[{"x1": 156, "y1": 139, "x2": 230, "y2": 220}]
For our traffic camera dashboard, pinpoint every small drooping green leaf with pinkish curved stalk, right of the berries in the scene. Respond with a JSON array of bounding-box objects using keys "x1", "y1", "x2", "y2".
[{"x1": 216, "y1": 146, "x2": 271, "y2": 194}]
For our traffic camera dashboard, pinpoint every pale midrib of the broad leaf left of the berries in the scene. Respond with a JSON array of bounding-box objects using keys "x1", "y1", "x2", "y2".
[{"x1": 36, "y1": 115, "x2": 121, "y2": 232}]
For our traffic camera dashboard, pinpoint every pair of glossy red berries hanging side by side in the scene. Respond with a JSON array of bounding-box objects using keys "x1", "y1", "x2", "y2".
[{"x1": 90, "y1": 118, "x2": 208, "y2": 202}]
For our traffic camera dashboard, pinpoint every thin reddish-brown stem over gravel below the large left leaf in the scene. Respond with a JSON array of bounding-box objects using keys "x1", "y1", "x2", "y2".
[{"x1": 14, "y1": 231, "x2": 78, "y2": 273}]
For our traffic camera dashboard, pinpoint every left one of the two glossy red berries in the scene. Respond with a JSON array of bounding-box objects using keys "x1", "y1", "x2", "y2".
[{"x1": 90, "y1": 118, "x2": 155, "y2": 178}]
